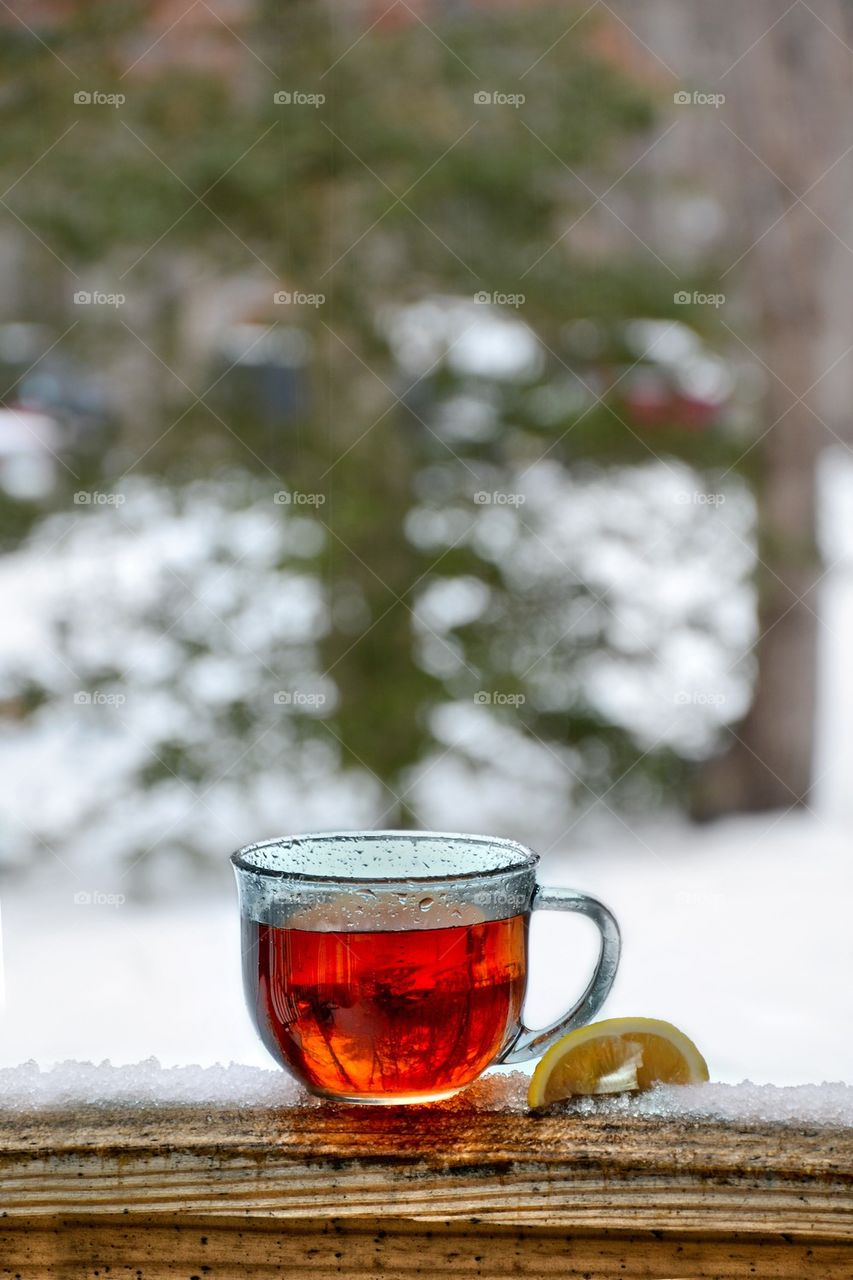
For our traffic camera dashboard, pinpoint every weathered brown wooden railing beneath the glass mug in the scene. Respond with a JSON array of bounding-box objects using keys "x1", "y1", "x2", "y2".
[{"x1": 0, "y1": 1100, "x2": 853, "y2": 1280}]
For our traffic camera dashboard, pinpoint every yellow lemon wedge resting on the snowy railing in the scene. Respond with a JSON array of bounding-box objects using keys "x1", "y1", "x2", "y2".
[{"x1": 528, "y1": 1018, "x2": 708, "y2": 1107}]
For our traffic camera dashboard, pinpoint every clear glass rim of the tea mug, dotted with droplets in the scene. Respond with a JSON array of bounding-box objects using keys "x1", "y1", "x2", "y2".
[{"x1": 231, "y1": 829, "x2": 539, "y2": 884}]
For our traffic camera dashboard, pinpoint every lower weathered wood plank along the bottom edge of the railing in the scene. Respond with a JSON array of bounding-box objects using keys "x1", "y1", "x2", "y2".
[{"x1": 0, "y1": 1215, "x2": 853, "y2": 1280}]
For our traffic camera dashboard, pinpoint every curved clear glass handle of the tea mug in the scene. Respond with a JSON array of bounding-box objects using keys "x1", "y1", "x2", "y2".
[{"x1": 497, "y1": 884, "x2": 621, "y2": 1062}]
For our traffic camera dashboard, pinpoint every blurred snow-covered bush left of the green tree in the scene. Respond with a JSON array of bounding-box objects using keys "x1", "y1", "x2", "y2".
[{"x1": 0, "y1": 476, "x2": 373, "y2": 888}]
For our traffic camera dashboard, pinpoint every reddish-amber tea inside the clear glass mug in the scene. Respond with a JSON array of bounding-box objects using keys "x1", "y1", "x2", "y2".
[{"x1": 243, "y1": 915, "x2": 528, "y2": 1101}]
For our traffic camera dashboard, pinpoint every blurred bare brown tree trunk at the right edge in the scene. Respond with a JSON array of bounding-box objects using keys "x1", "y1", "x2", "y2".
[{"x1": 622, "y1": 0, "x2": 853, "y2": 817}]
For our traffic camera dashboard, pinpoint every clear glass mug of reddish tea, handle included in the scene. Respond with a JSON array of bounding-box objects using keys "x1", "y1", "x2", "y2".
[{"x1": 232, "y1": 831, "x2": 620, "y2": 1103}]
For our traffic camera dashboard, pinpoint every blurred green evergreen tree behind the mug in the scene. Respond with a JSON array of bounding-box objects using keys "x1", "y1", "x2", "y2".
[{"x1": 0, "y1": 0, "x2": 731, "y2": 822}]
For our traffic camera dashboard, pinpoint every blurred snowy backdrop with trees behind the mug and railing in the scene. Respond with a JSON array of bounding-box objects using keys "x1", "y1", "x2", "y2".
[{"x1": 0, "y1": 0, "x2": 853, "y2": 1083}]
